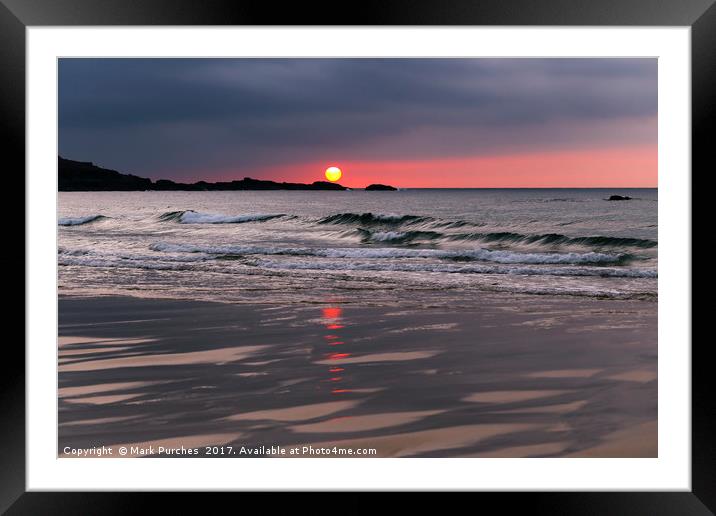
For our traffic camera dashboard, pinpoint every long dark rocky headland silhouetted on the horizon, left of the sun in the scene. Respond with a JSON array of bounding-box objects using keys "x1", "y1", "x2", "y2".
[{"x1": 58, "y1": 157, "x2": 347, "y2": 192}]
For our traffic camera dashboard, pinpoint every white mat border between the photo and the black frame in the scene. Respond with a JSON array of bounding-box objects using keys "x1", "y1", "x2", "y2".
[{"x1": 26, "y1": 27, "x2": 691, "y2": 490}]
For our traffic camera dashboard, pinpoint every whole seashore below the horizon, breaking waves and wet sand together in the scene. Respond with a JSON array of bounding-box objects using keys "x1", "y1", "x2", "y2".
[{"x1": 57, "y1": 189, "x2": 658, "y2": 458}]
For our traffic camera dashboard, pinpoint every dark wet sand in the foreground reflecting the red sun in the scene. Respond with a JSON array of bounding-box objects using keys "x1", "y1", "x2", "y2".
[{"x1": 58, "y1": 296, "x2": 658, "y2": 457}]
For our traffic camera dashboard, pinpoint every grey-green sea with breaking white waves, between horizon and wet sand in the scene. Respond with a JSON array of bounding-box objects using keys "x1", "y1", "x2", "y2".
[{"x1": 58, "y1": 189, "x2": 658, "y2": 306}]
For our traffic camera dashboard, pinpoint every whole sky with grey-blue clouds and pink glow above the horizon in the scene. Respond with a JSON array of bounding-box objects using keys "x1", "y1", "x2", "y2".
[{"x1": 58, "y1": 58, "x2": 657, "y2": 188}]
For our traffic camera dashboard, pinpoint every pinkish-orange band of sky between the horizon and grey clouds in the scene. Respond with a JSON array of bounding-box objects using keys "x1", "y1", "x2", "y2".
[{"x1": 182, "y1": 145, "x2": 658, "y2": 188}]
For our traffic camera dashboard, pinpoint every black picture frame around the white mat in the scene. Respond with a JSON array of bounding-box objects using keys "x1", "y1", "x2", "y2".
[{"x1": 0, "y1": 0, "x2": 716, "y2": 515}]
